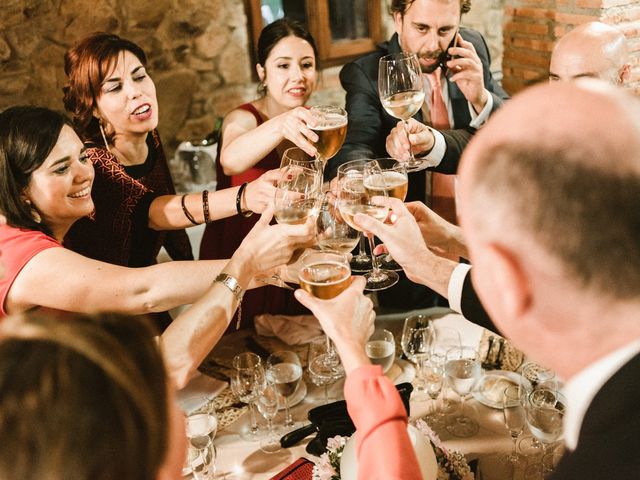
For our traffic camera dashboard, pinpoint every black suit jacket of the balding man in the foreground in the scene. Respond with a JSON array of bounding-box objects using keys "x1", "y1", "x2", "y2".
[{"x1": 551, "y1": 350, "x2": 640, "y2": 480}]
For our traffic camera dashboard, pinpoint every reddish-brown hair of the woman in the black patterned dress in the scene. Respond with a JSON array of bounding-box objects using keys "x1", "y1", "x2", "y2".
[{"x1": 62, "y1": 32, "x2": 147, "y2": 142}]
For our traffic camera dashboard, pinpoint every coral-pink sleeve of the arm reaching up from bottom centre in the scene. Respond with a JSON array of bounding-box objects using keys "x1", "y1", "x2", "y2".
[{"x1": 344, "y1": 365, "x2": 422, "y2": 480}]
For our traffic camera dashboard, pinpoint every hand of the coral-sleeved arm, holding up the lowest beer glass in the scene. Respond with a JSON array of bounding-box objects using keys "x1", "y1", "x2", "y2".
[{"x1": 295, "y1": 277, "x2": 375, "y2": 374}]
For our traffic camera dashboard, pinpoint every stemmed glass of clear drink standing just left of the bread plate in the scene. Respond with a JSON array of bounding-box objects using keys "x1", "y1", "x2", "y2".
[{"x1": 444, "y1": 347, "x2": 481, "y2": 437}]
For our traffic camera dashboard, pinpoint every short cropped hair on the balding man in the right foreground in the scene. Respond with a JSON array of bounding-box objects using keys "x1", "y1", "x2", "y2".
[{"x1": 468, "y1": 85, "x2": 640, "y2": 299}]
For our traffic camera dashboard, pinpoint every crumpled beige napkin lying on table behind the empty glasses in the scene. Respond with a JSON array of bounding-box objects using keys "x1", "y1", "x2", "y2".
[{"x1": 255, "y1": 313, "x2": 323, "y2": 345}]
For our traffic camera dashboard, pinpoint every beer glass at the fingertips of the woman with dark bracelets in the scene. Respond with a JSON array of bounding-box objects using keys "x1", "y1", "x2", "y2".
[{"x1": 273, "y1": 164, "x2": 322, "y2": 225}]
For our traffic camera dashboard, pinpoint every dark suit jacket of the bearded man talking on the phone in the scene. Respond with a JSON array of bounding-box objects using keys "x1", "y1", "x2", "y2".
[{"x1": 325, "y1": 28, "x2": 508, "y2": 201}]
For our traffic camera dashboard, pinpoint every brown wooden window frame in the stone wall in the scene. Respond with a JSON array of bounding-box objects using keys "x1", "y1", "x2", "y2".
[{"x1": 245, "y1": 0, "x2": 383, "y2": 68}]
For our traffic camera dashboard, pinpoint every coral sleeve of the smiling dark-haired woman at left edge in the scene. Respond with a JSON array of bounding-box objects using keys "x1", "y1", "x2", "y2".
[{"x1": 0, "y1": 225, "x2": 62, "y2": 318}]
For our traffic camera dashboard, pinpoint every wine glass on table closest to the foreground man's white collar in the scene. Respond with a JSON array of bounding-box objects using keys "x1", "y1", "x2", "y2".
[{"x1": 525, "y1": 388, "x2": 566, "y2": 477}]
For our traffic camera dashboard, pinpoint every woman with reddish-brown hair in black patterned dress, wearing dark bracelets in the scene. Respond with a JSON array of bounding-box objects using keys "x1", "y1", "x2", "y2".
[{"x1": 64, "y1": 33, "x2": 277, "y2": 267}]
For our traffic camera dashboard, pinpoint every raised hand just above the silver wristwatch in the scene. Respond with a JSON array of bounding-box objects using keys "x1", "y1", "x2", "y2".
[{"x1": 234, "y1": 205, "x2": 315, "y2": 275}]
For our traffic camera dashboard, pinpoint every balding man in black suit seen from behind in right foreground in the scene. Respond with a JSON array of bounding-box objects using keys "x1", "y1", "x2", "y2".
[{"x1": 355, "y1": 80, "x2": 640, "y2": 480}]
